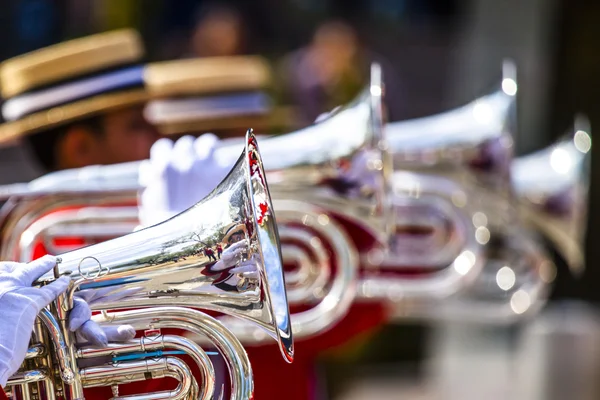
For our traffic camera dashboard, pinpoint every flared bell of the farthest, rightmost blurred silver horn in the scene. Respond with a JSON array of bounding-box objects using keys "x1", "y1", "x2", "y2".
[{"x1": 511, "y1": 116, "x2": 592, "y2": 274}]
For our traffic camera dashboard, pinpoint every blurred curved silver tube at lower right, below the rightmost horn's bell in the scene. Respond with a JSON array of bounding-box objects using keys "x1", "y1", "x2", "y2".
[{"x1": 394, "y1": 227, "x2": 556, "y2": 325}]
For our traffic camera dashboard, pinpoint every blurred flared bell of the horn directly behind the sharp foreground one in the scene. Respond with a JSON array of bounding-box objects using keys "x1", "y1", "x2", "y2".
[{"x1": 216, "y1": 64, "x2": 393, "y2": 241}]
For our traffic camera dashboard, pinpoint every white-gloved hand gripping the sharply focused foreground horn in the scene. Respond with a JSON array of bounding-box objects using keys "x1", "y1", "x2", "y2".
[{"x1": 0, "y1": 256, "x2": 135, "y2": 399}]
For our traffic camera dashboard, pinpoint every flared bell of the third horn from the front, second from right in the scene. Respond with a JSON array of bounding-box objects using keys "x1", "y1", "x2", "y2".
[{"x1": 386, "y1": 61, "x2": 517, "y2": 234}]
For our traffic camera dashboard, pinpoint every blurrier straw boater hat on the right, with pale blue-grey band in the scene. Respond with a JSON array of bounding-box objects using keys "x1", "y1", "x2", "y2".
[{"x1": 145, "y1": 56, "x2": 298, "y2": 134}]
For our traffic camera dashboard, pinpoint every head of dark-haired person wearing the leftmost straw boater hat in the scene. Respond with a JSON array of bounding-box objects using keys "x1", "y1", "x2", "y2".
[{"x1": 0, "y1": 29, "x2": 159, "y2": 172}]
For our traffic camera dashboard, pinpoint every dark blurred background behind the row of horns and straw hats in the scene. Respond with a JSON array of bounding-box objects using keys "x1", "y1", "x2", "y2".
[{"x1": 0, "y1": 0, "x2": 600, "y2": 400}]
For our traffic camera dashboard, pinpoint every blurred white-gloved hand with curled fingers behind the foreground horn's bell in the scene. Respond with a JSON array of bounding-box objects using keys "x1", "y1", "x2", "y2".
[{"x1": 139, "y1": 133, "x2": 232, "y2": 226}]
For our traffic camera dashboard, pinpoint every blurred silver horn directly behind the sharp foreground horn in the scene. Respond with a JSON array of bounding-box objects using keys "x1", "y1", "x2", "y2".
[{"x1": 4, "y1": 65, "x2": 392, "y2": 343}]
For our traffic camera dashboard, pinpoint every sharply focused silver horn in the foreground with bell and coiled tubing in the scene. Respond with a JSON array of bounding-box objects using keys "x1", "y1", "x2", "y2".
[{"x1": 3, "y1": 132, "x2": 293, "y2": 399}]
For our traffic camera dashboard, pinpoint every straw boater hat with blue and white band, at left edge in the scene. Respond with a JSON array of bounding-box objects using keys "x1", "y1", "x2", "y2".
[{"x1": 0, "y1": 29, "x2": 147, "y2": 143}]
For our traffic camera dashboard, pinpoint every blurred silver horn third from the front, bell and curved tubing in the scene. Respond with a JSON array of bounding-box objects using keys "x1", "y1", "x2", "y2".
[{"x1": 352, "y1": 61, "x2": 516, "y2": 313}]
